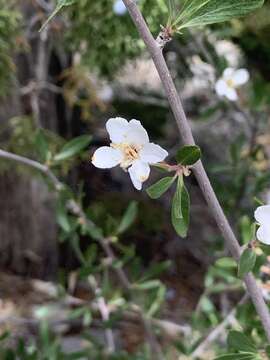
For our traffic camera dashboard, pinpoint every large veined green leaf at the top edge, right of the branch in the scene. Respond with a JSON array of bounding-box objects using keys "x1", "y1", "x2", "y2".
[{"x1": 174, "y1": 0, "x2": 264, "y2": 31}]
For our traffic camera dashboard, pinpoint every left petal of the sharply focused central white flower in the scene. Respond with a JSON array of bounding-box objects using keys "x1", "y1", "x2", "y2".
[{"x1": 92, "y1": 146, "x2": 123, "y2": 169}]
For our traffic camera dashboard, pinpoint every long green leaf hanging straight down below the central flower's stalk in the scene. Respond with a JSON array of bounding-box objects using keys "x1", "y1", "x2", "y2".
[{"x1": 171, "y1": 184, "x2": 190, "y2": 237}]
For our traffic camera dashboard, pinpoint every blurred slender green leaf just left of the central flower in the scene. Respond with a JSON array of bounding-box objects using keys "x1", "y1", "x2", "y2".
[{"x1": 54, "y1": 135, "x2": 92, "y2": 161}]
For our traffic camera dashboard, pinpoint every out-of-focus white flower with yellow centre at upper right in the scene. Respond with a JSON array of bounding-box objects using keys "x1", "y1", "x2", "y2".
[{"x1": 216, "y1": 68, "x2": 249, "y2": 101}]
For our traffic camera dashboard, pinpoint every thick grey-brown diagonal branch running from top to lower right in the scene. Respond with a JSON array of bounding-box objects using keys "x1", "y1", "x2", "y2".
[{"x1": 123, "y1": 0, "x2": 270, "y2": 341}]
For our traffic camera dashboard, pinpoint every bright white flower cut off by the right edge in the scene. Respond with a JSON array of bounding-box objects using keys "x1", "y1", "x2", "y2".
[{"x1": 254, "y1": 205, "x2": 270, "y2": 245}]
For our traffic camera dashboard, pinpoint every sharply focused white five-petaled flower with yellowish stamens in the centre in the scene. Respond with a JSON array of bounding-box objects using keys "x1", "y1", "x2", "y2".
[{"x1": 92, "y1": 117, "x2": 168, "y2": 190}]
